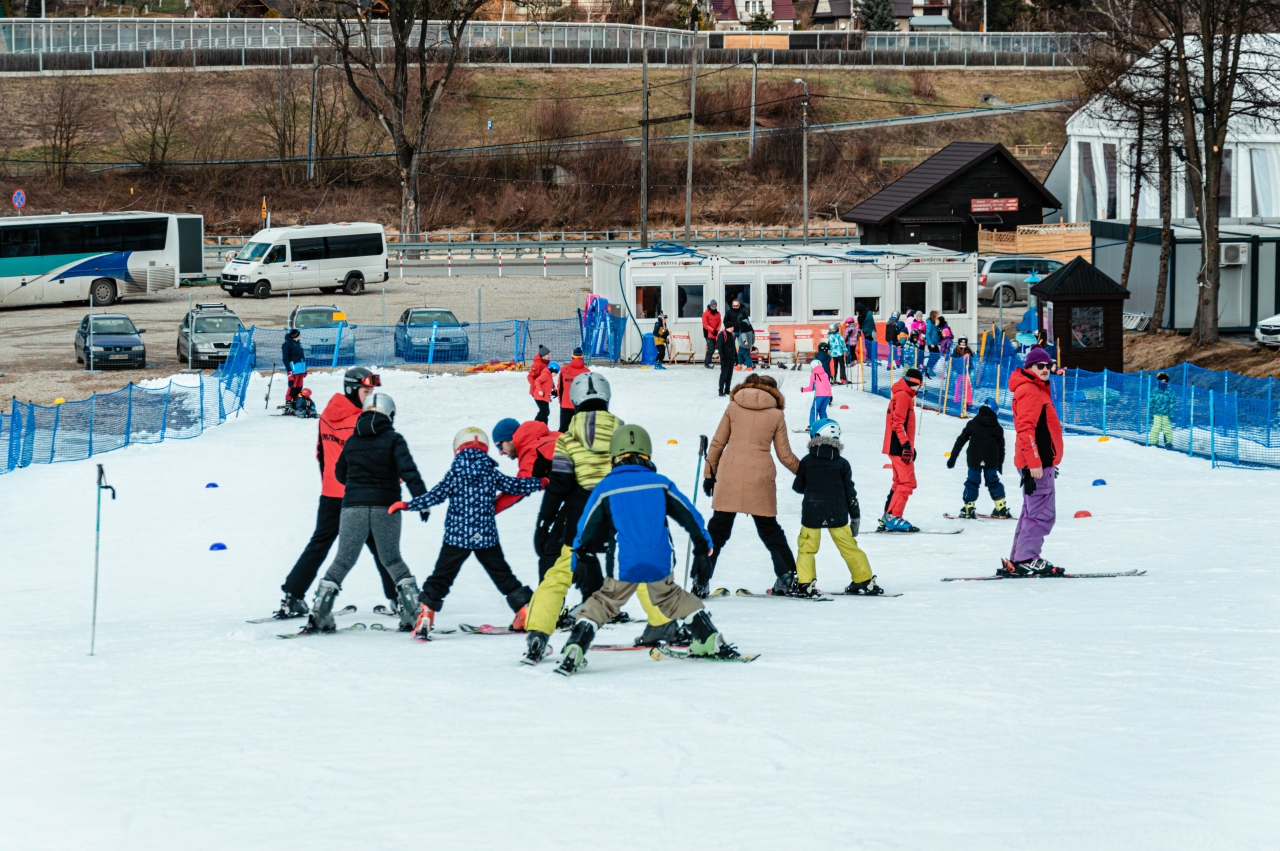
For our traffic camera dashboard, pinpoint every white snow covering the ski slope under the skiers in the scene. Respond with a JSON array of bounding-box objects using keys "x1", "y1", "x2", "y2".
[{"x1": 0, "y1": 367, "x2": 1280, "y2": 850}]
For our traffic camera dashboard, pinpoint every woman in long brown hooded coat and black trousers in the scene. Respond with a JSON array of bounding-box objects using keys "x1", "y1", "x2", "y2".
[{"x1": 692, "y1": 374, "x2": 800, "y2": 598}]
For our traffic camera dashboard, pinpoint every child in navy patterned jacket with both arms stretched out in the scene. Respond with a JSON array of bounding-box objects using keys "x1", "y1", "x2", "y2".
[{"x1": 388, "y1": 426, "x2": 543, "y2": 639}]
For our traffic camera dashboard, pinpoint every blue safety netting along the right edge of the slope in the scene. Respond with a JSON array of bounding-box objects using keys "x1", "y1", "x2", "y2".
[{"x1": 863, "y1": 343, "x2": 1280, "y2": 467}]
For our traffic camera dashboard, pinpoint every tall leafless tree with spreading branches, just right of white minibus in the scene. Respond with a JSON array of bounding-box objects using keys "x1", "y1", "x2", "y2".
[{"x1": 298, "y1": 0, "x2": 485, "y2": 233}]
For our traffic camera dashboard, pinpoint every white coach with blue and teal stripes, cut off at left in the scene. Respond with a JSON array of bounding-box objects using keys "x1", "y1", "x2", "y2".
[{"x1": 0, "y1": 211, "x2": 205, "y2": 307}]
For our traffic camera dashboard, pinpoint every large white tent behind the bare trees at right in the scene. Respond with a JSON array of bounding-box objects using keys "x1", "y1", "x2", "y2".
[{"x1": 1059, "y1": 36, "x2": 1280, "y2": 221}]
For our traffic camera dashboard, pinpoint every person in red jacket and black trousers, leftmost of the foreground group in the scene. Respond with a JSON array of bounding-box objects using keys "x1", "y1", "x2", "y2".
[{"x1": 275, "y1": 366, "x2": 399, "y2": 621}]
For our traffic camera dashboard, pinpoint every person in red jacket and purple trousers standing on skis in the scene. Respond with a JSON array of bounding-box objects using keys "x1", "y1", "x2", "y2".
[{"x1": 1000, "y1": 346, "x2": 1064, "y2": 576}]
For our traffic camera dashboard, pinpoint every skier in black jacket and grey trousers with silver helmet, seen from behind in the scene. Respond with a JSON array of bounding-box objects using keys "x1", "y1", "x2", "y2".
[{"x1": 305, "y1": 393, "x2": 430, "y2": 632}]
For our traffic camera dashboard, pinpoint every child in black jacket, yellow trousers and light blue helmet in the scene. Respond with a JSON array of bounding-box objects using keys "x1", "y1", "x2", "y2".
[{"x1": 791, "y1": 418, "x2": 884, "y2": 596}]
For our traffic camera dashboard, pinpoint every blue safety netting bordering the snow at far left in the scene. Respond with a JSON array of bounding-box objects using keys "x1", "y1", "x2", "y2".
[{"x1": 0, "y1": 330, "x2": 253, "y2": 473}]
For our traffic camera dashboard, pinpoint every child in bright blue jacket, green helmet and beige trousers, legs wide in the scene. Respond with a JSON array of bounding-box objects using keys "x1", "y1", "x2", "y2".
[{"x1": 557, "y1": 425, "x2": 739, "y2": 677}]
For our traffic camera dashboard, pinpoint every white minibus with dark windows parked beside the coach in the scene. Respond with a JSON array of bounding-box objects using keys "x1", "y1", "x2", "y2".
[{"x1": 221, "y1": 221, "x2": 390, "y2": 298}]
